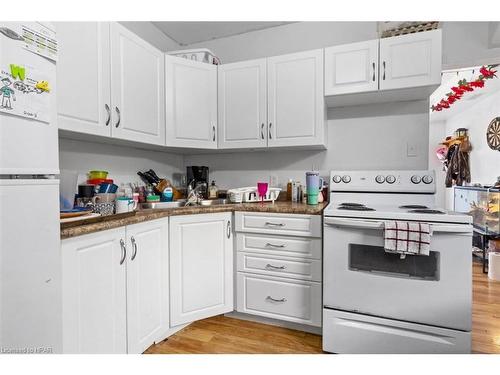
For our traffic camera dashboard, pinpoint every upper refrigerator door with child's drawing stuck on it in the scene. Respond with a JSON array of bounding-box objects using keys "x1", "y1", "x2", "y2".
[{"x1": 0, "y1": 22, "x2": 59, "y2": 175}]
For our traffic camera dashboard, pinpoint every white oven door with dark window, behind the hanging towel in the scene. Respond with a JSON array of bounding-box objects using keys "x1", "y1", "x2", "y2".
[{"x1": 323, "y1": 217, "x2": 472, "y2": 331}]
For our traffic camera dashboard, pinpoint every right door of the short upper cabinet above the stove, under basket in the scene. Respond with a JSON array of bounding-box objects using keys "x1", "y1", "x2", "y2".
[{"x1": 380, "y1": 30, "x2": 441, "y2": 90}]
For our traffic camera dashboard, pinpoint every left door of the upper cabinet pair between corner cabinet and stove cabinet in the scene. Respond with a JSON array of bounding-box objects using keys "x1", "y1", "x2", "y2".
[{"x1": 218, "y1": 59, "x2": 267, "y2": 148}]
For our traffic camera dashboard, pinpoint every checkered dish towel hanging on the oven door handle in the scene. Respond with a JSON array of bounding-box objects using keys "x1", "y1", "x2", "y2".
[{"x1": 384, "y1": 221, "x2": 432, "y2": 257}]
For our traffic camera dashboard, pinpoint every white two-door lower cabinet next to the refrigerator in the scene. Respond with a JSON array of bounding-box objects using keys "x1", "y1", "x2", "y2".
[{"x1": 61, "y1": 218, "x2": 169, "y2": 354}]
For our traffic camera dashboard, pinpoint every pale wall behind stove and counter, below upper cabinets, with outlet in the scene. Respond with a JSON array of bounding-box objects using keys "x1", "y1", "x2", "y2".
[{"x1": 184, "y1": 101, "x2": 429, "y2": 187}]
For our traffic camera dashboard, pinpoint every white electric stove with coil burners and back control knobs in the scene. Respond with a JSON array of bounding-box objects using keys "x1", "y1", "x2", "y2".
[{"x1": 323, "y1": 171, "x2": 472, "y2": 353}]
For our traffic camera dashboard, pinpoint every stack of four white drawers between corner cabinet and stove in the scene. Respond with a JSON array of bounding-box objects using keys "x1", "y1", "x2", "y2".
[{"x1": 236, "y1": 212, "x2": 322, "y2": 327}]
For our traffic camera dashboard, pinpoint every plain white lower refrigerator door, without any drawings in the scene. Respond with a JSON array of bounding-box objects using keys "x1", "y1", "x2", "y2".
[{"x1": 0, "y1": 179, "x2": 62, "y2": 353}]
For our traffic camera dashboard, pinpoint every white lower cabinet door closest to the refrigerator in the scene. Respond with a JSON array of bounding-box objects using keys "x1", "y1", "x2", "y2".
[{"x1": 61, "y1": 228, "x2": 128, "y2": 354}]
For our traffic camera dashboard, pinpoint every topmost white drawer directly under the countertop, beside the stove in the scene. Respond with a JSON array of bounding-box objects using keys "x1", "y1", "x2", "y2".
[{"x1": 236, "y1": 212, "x2": 321, "y2": 237}]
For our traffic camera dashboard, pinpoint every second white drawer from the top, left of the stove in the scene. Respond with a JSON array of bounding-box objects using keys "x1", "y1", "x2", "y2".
[{"x1": 236, "y1": 233, "x2": 322, "y2": 259}]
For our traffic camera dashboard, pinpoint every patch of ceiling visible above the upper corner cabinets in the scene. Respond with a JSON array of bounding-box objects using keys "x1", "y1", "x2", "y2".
[{"x1": 153, "y1": 21, "x2": 291, "y2": 46}]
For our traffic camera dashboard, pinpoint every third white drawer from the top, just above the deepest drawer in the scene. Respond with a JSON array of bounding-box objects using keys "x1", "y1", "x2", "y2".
[{"x1": 237, "y1": 252, "x2": 321, "y2": 281}]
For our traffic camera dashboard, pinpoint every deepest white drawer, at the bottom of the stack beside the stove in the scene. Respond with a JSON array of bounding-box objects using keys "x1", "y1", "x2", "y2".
[{"x1": 236, "y1": 272, "x2": 322, "y2": 327}]
